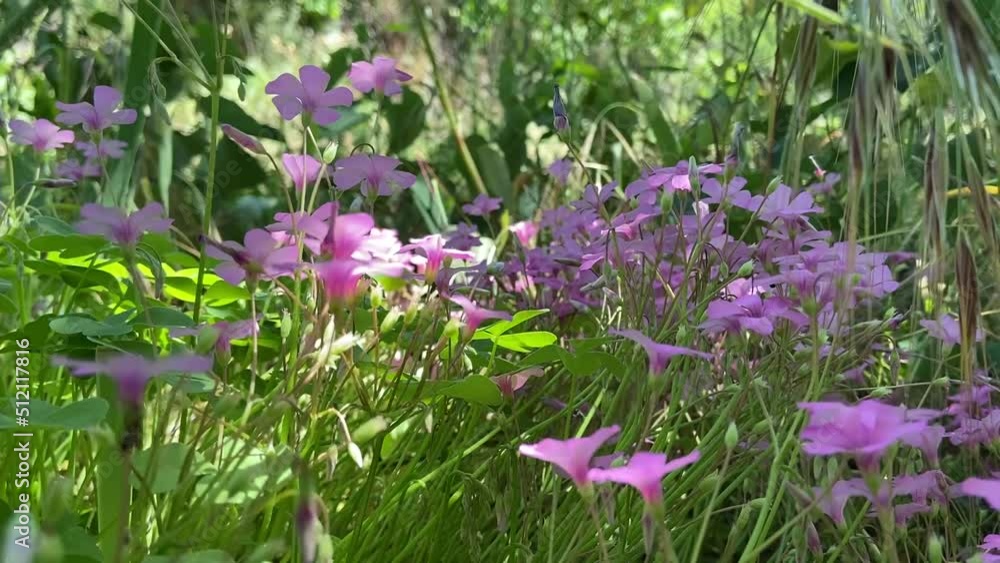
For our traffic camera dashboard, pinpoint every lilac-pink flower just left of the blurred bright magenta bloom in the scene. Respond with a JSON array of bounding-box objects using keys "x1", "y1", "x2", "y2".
[{"x1": 205, "y1": 229, "x2": 299, "y2": 285}]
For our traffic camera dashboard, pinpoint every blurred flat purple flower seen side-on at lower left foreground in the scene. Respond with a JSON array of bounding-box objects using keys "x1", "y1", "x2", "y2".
[{"x1": 53, "y1": 354, "x2": 212, "y2": 405}]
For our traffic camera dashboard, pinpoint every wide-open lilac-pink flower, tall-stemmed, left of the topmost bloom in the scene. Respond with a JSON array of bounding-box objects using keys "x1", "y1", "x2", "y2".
[{"x1": 264, "y1": 65, "x2": 354, "y2": 125}]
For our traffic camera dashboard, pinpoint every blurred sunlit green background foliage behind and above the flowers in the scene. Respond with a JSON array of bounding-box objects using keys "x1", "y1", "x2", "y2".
[{"x1": 0, "y1": 0, "x2": 1000, "y2": 289}]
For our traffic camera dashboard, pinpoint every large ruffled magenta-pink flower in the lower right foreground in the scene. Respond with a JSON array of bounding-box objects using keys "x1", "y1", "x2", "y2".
[{"x1": 799, "y1": 400, "x2": 927, "y2": 472}]
